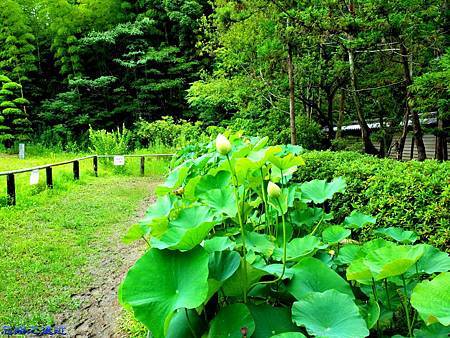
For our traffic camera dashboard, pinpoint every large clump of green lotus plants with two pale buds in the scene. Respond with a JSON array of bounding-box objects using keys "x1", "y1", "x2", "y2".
[{"x1": 119, "y1": 135, "x2": 450, "y2": 338}]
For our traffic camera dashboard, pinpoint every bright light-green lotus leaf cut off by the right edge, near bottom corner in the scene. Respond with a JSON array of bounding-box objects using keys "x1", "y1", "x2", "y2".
[{"x1": 411, "y1": 272, "x2": 450, "y2": 326}]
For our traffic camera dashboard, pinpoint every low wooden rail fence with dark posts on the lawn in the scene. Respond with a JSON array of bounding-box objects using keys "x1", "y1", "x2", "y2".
[{"x1": 0, "y1": 154, "x2": 174, "y2": 205}]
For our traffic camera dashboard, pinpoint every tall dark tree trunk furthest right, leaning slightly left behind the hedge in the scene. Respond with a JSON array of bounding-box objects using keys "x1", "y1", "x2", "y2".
[{"x1": 400, "y1": 43, "x2": 427, "y2": 161}]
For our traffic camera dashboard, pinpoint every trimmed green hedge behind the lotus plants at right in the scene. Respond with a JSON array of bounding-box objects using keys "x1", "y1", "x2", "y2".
[{"x1": 295, "y1": 151, "x2": 450, "y2": 251}]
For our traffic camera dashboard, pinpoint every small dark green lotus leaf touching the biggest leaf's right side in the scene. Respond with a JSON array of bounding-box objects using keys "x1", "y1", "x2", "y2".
[{"x1": 209, "y1": 251, "x2": 241, "y2": 282}]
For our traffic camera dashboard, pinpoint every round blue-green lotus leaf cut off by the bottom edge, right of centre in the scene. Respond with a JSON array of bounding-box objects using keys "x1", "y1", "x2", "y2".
[{"x1": 292, "y1": 290, "x2": 369, "y2": 338}]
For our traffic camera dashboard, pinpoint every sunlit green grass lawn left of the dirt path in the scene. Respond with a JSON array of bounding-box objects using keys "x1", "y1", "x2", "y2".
[{"x1": 0, "y1": 154, "x2": 167, "y2": 326}]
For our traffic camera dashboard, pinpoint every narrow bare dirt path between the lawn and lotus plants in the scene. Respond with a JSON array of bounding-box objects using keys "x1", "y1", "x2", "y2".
[{"x1": 56, "y1": 182, "x2": 158, "y2": 337}]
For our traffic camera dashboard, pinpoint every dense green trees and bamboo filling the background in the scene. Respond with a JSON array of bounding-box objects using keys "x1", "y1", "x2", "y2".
[{"x1": 0, "y1": 0, "x2": 450, "y2": 159}]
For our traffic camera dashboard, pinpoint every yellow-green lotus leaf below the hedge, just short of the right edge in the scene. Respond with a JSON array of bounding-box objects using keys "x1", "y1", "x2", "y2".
[{"x1": 364, "y1": 245, "x2": 424, "y2": 280}]
